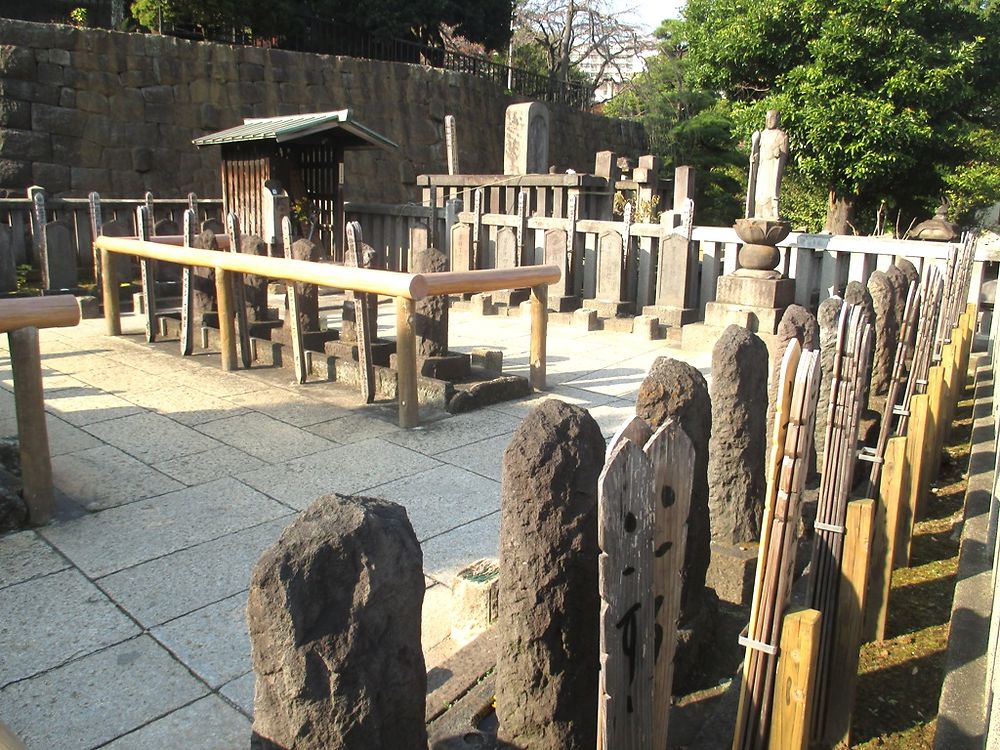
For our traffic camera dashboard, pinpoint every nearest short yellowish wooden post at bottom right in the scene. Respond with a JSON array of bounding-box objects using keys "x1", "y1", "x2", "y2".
[{"x1": 767, "y1": 609, "x2": 822, "y2": 750}]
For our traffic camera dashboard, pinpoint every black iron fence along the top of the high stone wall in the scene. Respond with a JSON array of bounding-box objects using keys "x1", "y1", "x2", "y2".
[{"x1": 0, "y1": 0, "x2": 592, "y2": 110}]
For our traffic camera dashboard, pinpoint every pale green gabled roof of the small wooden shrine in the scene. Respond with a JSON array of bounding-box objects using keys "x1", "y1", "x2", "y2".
[{"x1": 192, "y1": 109, "x2": 399, "y2": 149}]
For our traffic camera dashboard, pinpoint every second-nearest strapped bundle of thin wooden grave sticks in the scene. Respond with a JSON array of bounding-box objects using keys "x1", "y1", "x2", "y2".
[{"x1": 807, "y1": 305, "x2": 872, "y2": 739}]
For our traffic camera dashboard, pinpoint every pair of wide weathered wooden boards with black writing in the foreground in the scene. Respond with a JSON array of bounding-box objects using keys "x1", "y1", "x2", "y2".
[{"x1": 598, "y1": 417, "x2": 694, "y2": 750}]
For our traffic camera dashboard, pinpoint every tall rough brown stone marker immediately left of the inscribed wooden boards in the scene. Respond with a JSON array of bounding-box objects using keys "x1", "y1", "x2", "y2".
[{"x1": 496, "y1": 399, "x2": 604, "y2": 750}]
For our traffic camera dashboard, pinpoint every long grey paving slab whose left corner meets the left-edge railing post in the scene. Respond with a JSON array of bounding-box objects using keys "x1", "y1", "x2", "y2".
[{"x1": 41, "y1": 478, "x2": 288, "y2": 578}]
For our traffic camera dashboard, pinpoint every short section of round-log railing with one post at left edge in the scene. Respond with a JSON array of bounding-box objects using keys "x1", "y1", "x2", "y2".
[{"x1": 0, "y1": 295, "x2": 80, "y2": 526}]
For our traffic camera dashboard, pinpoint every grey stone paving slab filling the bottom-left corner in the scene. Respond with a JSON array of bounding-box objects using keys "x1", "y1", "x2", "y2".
[{"x1": 0, "y1": 635, "x2": 208, "y2": 750}]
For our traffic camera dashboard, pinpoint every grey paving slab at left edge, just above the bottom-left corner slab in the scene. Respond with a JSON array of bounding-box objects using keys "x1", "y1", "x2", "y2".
[{"x1": 0, "y1": 570, "x2": 140, "y2": 685}]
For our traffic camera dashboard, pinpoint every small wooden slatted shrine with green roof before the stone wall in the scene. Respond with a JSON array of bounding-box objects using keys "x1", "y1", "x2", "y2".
[{"x1": 193, "y1": 109, "x2": 399, "y2": 259}]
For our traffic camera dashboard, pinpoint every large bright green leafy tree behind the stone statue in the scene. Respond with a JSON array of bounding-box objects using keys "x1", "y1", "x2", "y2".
[{"x1": 684, "y1": 0, "x2": 1000, "y2": 233}]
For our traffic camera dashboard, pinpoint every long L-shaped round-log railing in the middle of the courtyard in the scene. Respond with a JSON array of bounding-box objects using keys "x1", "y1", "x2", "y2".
[{"x1": 95, "y1": 235, "x2": 559, "y2": 427}]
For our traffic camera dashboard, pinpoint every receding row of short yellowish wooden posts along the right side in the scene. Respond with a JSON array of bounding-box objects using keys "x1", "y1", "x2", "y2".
[{"x1": 734, "y1": 304, "x2": 978, "y2": 750}]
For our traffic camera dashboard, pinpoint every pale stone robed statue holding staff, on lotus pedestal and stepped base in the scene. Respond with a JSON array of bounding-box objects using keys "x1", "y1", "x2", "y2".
[{"x1": 705, "y1": 109, "x2": 795, "y2": 334}]
